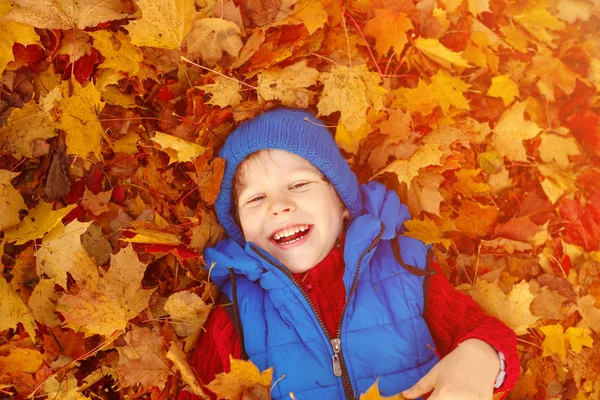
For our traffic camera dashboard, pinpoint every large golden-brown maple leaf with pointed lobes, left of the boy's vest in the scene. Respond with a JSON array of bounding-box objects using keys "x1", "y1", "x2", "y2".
[{"x1": 56, "y1": 246, "x2": 156, "y2": 337}]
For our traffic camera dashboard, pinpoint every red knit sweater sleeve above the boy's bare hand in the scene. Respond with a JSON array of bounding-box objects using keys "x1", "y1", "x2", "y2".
[{"x1": 425, "y1": 262, "x2": 520, "y2": 393}]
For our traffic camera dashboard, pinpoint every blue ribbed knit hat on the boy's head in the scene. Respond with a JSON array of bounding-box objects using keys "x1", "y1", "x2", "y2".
[{"x1": 215, "y1": 108, "x2": 362, "y2": 246}]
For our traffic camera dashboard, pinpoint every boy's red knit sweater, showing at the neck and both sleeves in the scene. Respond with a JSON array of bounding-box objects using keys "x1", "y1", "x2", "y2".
[{"x1": 178, "y1": 239, "x2": 519, "y2": 400}]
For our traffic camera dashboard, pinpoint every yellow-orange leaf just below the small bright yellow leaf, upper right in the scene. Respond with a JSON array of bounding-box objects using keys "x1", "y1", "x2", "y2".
[{"x1": 492, "y1": 102, "x2": 542, "y2": 161}]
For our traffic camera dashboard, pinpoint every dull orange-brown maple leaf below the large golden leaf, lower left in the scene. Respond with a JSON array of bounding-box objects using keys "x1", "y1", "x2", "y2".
[{"x1": 116, "y1": 325, "x2": 171, "y2": 391}]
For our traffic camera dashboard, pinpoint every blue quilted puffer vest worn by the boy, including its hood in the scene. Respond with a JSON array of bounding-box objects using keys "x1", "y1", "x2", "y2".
[{"x1": 204, "y1": 182, "x2": 438, "y2": 400}]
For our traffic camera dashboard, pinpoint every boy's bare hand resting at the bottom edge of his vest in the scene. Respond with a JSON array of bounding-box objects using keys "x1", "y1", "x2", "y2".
[{"x1": 402, "y1": 339, "x2": 500, "y2": 400}]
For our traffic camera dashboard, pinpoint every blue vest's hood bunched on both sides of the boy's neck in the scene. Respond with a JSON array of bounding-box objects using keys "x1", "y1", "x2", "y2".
[{"x1": 204, "y1": 181, "x2": 410, "y2": 293}]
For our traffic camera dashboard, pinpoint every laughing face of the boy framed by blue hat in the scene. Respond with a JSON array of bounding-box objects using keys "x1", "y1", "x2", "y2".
[{"x1": 237, "y1": 149, "x2": 349, "y2": 273}]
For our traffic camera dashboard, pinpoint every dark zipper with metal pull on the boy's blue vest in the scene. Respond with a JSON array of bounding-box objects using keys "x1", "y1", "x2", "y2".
[{"x1": 250, "y1": 222, "x2": 384, "y2": 400}]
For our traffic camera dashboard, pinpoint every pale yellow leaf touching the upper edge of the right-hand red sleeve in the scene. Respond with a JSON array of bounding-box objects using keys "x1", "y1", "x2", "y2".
[{"x1": 469, "y1": 279, "x2": 538, "y2": 336}]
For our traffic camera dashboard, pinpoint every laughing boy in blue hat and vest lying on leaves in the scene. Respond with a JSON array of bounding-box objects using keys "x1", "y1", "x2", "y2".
[{"x1": 182, "y1": 109, "x2": 519, "y2": 400}]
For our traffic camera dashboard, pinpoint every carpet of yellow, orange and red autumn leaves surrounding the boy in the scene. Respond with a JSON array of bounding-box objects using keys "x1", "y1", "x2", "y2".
[{"x1": 0, "y1": 0, "x2": 600, "y2": 400}]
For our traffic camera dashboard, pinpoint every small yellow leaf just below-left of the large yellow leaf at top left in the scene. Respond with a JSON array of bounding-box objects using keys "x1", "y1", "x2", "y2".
[{"x1": 89, "y1": 31, "x2": 144, "y2": 75}]
